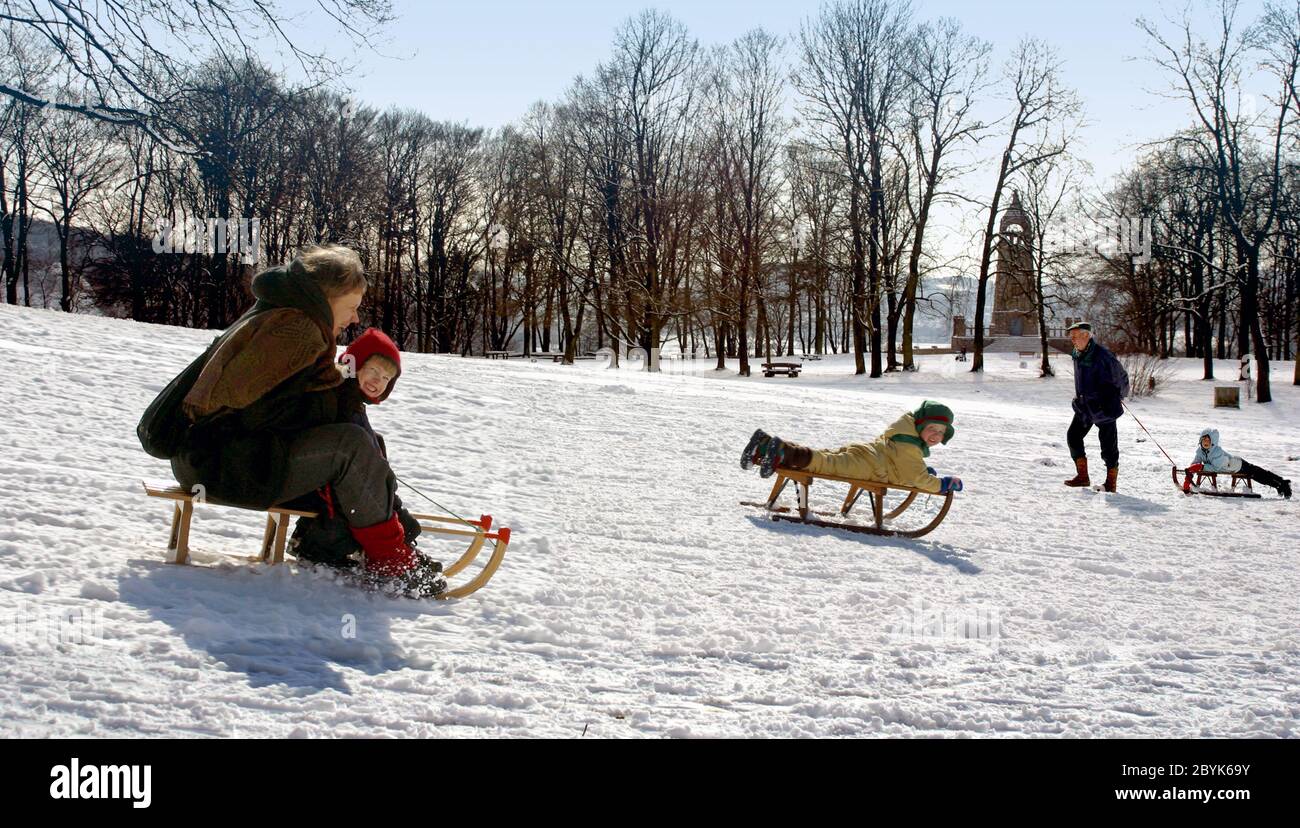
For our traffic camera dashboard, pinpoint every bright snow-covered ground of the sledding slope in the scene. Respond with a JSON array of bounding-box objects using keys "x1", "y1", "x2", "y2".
[{"x1": 0, "y1": 305, "x2": 1300, "y2": 737}]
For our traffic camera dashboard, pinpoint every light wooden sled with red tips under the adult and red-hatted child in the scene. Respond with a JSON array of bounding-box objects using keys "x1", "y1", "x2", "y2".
[{"x1": 140, "y1": 481, "x2": 510, "y2": 598}]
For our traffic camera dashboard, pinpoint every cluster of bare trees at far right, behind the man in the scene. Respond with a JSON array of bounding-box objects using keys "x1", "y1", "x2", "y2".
[{"x1": 1097, "y1": 0, "x2": 1300, "y2": 402}]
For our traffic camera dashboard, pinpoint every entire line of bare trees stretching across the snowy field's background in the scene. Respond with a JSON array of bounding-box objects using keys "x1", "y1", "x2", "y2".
[{"x1": 0, "y1": 0, "x2": 1300, "y2": 396}]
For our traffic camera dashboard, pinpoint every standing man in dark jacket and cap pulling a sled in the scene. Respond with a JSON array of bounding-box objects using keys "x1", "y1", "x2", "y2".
[{"x1": 1065, "y1": 322, "x2": 1128, "y2": 491}]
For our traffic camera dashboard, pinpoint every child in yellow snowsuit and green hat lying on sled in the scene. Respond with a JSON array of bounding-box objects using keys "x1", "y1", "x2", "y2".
[{"x1": 740, "y1": 400, "x2": 962, "y2": 494}]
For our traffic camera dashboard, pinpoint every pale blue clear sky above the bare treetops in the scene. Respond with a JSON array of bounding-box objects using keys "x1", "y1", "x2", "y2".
[{"x1": 285, "y1": 0, "x2": 1268, "y2": 181}]
